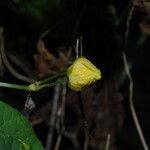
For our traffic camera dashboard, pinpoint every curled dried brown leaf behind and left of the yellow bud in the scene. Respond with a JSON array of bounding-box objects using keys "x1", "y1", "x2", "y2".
[{"x1": 34, "y1": 40, "x2": 70, "y2": 78}]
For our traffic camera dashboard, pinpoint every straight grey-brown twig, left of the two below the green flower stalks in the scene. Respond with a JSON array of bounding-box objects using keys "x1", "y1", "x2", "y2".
[{"x1": 46, "y1": 84, "x2": 60, "y2": 150}]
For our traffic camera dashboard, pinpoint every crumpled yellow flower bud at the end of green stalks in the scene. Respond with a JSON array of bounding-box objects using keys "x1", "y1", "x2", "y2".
[{"x1": 67, "y1": 57, "x2": 101, "y2": 91}]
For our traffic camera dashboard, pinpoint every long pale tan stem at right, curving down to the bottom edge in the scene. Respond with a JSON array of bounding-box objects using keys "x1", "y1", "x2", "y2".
[{"x1": 123, "y1": 52, "x2": 149, "y2": 150}]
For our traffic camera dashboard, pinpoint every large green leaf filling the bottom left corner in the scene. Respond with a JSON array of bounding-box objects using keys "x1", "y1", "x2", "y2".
[{"x1": 0, "y1": 101, "x2": 44, "y2": 150}]
